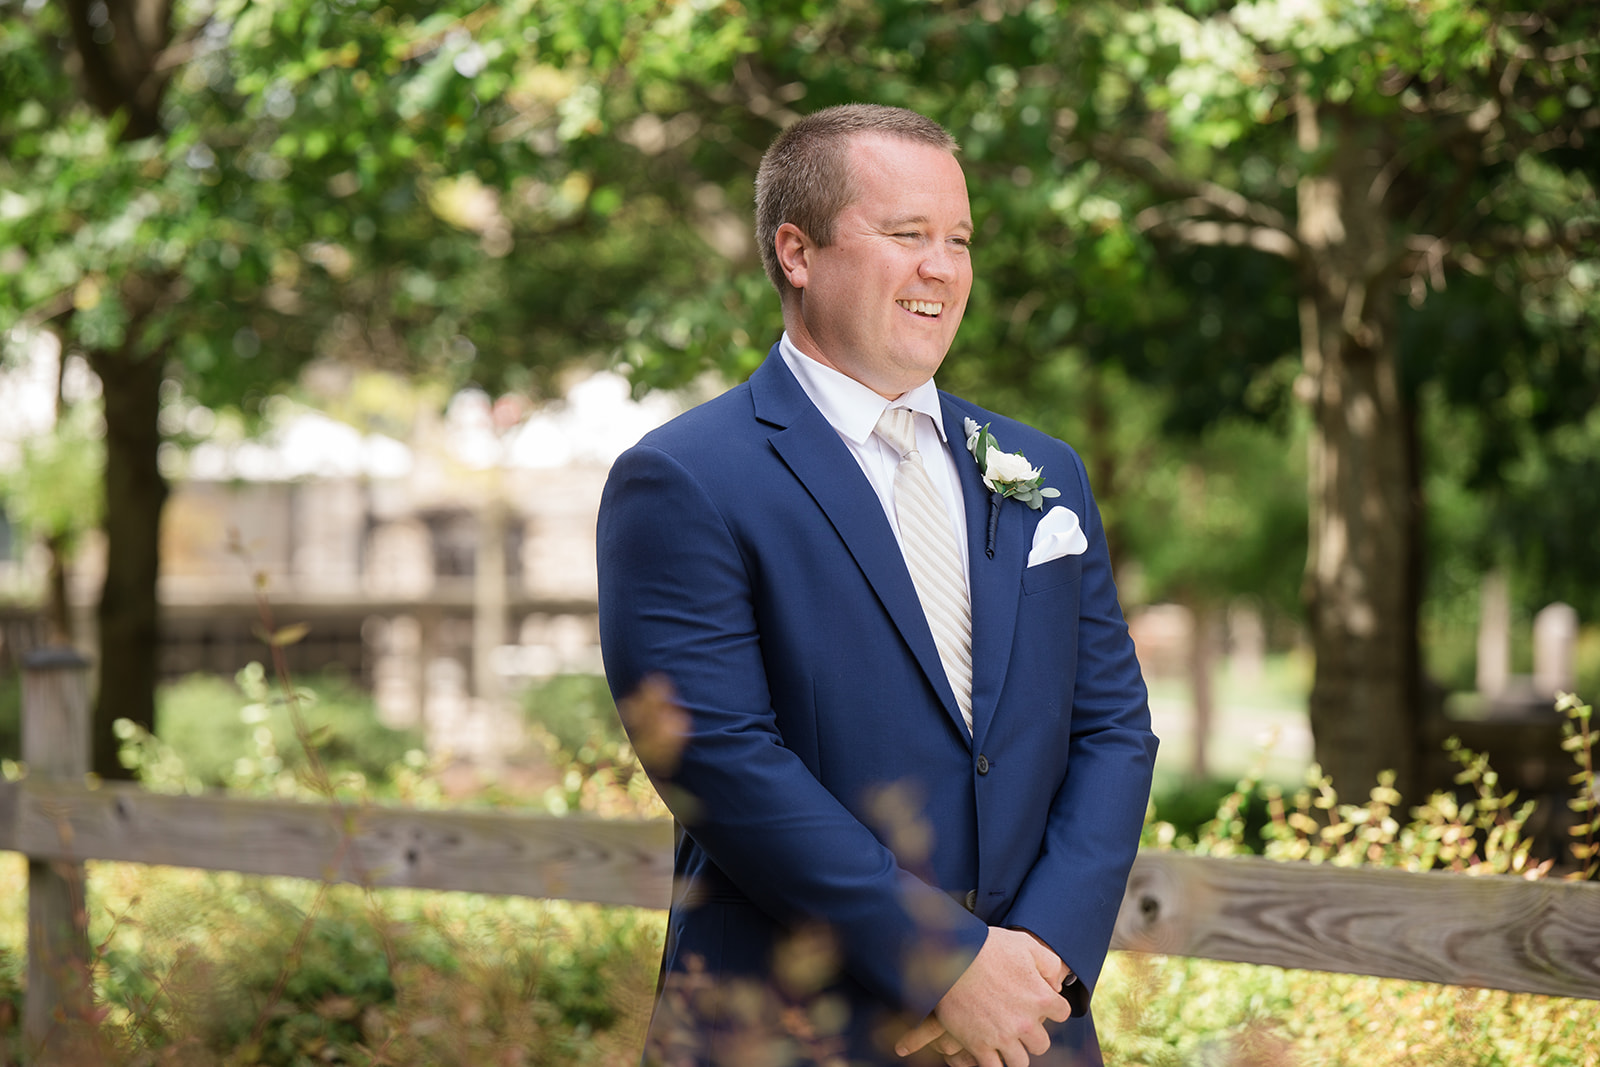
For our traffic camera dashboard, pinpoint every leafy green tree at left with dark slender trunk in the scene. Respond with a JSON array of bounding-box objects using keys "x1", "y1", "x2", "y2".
[{"x1": 0, "y1": 0, "x2": 755, "y2": 774}]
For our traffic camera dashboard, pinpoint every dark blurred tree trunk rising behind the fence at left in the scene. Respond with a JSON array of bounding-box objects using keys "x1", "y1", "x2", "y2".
[{"x1": 88, "y1": 347, "x2": 166, "y2": 777}]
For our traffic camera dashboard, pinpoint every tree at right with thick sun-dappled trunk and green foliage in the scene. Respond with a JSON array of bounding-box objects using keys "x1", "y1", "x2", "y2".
[{"x1": 1077, "y1": 0, "x2": 1600, "y2": 793}]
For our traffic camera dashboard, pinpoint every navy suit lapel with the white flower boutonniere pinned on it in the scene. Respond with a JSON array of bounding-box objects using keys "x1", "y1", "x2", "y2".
[{"x1": 939, "y1": 394, "x2": 1037, "y2": 745}]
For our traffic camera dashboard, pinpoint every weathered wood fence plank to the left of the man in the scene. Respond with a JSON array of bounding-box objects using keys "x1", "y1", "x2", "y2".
[{"x1": 0, "y1": 779, "x2": 672, "y2": 907}]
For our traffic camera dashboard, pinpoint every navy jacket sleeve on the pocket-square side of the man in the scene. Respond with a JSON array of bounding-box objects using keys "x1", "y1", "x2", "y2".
[{"x1": 1002, "y1": 464, "x2": 1157, "y2": 1014}]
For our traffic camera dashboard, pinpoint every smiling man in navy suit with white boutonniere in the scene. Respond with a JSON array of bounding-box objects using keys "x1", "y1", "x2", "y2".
[{"x1": 598, "y1": 106, "x2": 1157, "y2": 1067}]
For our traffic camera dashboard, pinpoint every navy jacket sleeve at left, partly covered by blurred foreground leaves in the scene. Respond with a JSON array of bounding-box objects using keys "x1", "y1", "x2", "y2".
[{"x1": 598, "y1": 443, "x2": 987, "y2": 1014}]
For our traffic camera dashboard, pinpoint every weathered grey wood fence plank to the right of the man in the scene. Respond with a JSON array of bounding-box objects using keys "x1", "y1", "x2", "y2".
[{"x1": 1112, "y1": 853, "x2": 1600, "y2": 1000}]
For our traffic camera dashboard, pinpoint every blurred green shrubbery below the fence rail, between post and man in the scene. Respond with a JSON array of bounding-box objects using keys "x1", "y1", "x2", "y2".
[{"x1": 76, "y1": 864, "x2": 662, "y2": 1067}]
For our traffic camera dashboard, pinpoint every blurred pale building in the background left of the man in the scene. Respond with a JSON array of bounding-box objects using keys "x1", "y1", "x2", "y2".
[{"x1": 0, "y1": 363, "x2": 678, "y2": 758}]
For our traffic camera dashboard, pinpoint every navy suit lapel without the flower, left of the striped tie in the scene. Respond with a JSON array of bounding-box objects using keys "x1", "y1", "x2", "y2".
[{"x1": 750, "y1": 346, "x2": 966, "y2": 736}]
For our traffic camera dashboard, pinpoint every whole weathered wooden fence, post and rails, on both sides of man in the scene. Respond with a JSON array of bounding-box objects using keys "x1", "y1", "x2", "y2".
[{"x1": 0, "y1": 649, "x2": 1600, "y2": 1053}]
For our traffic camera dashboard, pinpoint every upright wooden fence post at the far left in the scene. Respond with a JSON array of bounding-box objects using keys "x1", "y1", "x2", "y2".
[{"x1": 22, "y1": 646, "x2": 94, "y2": 1064}]
